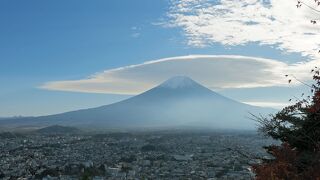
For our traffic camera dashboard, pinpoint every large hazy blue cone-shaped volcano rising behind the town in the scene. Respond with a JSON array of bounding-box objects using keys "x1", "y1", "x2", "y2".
[{"x1": 0, "y1": 76, "x2": 274, "y2": 129}]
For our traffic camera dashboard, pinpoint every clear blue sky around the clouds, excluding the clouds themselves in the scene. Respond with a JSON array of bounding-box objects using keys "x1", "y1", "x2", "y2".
[{"x1": 0, "y1": 0, "x2": 318, "y2": 117}]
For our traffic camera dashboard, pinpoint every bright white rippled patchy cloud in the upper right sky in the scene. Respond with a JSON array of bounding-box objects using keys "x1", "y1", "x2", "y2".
[{"x1": 165, "y1": 0, "x2": 320, "y2": 58}]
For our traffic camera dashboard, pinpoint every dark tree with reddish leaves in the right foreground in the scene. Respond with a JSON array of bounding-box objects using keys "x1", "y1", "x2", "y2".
[{"x1": 253, "y1": 67, "x2": 320, "y2": 180}]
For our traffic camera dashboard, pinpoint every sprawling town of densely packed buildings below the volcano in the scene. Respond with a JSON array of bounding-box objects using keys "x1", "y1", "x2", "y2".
[{"x1": 0, "y1": 130, "x2": 276, "y2": 180}]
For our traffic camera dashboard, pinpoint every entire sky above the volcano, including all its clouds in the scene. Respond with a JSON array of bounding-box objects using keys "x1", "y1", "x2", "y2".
[{"x1": 0, "y1": 0, "x2": 320, "y2": 117}]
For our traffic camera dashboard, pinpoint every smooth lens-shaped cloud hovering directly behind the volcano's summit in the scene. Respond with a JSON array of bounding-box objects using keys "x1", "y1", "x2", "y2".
[{"x1": 41, "y1": 55, "x2": 312, "y2": 94}]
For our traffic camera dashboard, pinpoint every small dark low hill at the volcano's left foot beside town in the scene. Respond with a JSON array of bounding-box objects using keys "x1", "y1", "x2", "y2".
[{"x1": 36, "y1": 125, "x2": 81, "y2": 134}]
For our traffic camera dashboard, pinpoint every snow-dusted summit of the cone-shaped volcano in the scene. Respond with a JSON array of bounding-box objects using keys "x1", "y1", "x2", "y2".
[{"x1": 160, "y1": 76, "x2": 197, "y2": 89}]
